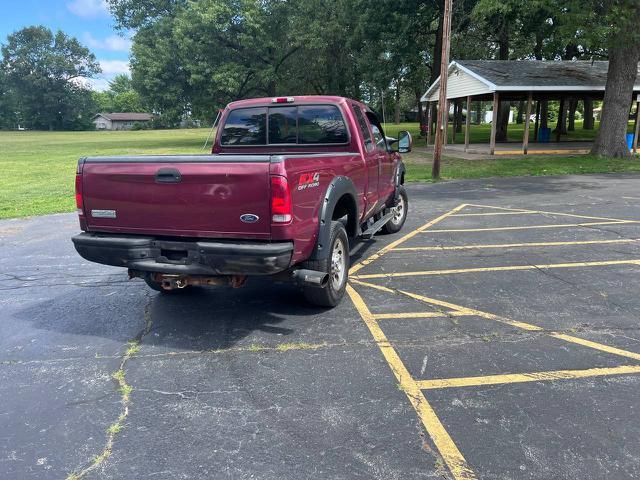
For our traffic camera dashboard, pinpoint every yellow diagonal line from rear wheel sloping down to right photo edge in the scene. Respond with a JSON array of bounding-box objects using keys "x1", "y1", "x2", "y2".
[{"x1": 351, "y1": 280, "x2": 640, "y2": 360}]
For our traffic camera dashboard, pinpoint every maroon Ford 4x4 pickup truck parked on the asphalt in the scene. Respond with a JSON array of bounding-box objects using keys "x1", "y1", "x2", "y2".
[{"x1": 73, "y1": 96, "x2": 411, "y2": 306}]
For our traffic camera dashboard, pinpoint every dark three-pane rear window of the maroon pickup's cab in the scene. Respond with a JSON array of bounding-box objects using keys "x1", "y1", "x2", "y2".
[{"x1": 220, "y1": 105, "x2": 349, "y2": 147}]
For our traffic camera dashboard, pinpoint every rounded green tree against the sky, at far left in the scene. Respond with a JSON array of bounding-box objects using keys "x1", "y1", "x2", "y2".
[{"x1": 1, "y1": 26, "x2": 100, "y2": 130}]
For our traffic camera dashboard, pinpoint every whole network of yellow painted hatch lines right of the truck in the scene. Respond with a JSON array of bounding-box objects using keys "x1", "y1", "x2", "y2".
[{"x1": 346, "y1": 204, "x2": 640, "y2": 480}]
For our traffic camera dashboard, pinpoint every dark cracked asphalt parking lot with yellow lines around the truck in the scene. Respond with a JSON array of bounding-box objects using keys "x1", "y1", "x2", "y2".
[{"x1": 0, "y1": 175, "x2": 640, "y2": 480}]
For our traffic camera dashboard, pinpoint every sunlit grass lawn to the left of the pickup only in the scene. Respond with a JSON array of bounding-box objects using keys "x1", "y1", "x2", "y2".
[{"x1": 0, "y1": 128, "x2": 211, "y2": 218}]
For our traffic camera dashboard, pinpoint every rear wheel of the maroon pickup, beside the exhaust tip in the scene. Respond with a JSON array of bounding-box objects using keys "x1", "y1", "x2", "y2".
[{"x1": 302, "y1": 221, "x2": 349, "y2": 307}]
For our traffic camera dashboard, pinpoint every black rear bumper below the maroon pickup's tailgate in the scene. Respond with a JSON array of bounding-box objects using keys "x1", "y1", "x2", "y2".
[{"x1": 72, "y1": 233, "x2": 293, "y2": 276}]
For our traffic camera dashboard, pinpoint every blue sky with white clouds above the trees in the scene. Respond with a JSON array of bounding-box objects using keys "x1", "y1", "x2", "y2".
[{"x1": 0, "y1": 0, "x2": 131, "y2": 90}]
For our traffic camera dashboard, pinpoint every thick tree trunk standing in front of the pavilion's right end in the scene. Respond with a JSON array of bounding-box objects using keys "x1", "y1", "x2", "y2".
[{"x1": 591, "y1": 41, "x2": 640, "y2": 157}]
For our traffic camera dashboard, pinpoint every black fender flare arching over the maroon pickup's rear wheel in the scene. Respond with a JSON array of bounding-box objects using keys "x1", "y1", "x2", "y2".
[{"x1": 311, "y1": 176, "x2": 360, "y2": 260}]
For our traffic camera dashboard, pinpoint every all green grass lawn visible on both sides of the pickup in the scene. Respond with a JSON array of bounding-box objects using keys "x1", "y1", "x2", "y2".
[{"x1": 0, "y1": 123, "x2": 640, "y2": 218}]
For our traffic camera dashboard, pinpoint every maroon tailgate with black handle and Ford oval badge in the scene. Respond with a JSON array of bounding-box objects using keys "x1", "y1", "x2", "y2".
[{"x1": 82, "y1": 155, "x2": 270, "y2": 239}]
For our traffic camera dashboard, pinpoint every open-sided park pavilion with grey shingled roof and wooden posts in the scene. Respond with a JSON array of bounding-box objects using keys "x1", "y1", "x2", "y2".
[{"x1": 421, "y1": 60, "x2": 640, "y2": 155}]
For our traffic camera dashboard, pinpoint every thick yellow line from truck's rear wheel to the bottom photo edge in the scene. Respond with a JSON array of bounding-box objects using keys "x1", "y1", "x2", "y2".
[{"x1": 347, "y1": 285, "x2": 477, "y2": 480}]
